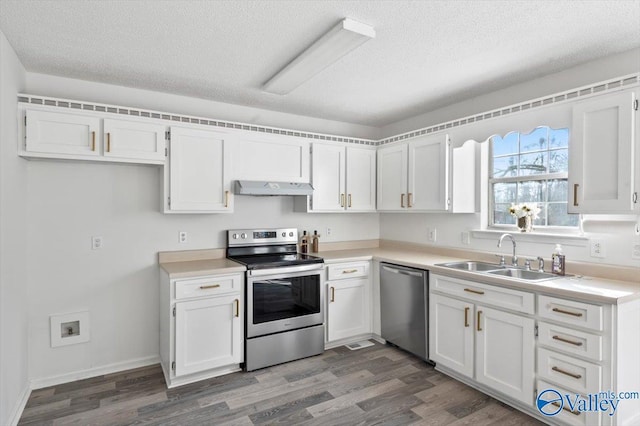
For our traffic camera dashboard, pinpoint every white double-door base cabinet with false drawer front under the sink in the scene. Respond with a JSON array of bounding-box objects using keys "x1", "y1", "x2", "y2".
[{"x1": 429, "y1": 274, "x2": 535, "y2": 406}]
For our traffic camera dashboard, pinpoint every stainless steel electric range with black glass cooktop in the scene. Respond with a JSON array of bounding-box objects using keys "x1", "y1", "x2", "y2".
[{"x1": 227, "y1": 228, "x2": 324, "y2": 371}]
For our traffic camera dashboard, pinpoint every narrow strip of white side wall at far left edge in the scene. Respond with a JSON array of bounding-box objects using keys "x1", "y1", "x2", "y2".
[{"x1": 0, "y1": 32, "x2": 28, "y2": 425}]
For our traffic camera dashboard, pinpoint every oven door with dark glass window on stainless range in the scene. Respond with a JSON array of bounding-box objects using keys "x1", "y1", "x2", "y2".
[{"x1": 247, "y1": 265, "x2": 324, "y2": 338}]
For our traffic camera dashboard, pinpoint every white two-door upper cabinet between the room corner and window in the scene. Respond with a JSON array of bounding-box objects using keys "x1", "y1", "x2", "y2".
[{"x1": 377, "y1": 134, "x2": 450, "y2": 211}]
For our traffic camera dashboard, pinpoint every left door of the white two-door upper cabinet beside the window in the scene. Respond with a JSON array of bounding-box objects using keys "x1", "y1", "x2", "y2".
[{"x1": 377, "y1": 144, "x2": 407, "y2": 211}]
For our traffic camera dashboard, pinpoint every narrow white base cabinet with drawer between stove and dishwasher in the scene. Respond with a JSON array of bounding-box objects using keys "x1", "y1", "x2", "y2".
[{"x1": 326, "y1": 262, "x2": 371, "y2": 346}]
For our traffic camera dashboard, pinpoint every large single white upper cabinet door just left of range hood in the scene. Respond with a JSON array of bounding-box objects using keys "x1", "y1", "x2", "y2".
[{"x1": 169, "y1": 127, "x2": 233, "y2": 213}]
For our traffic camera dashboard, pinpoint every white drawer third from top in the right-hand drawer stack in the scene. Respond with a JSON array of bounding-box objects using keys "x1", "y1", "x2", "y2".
[{"x1": 538, "y1": 348, "x2": 602, "y2": 394}]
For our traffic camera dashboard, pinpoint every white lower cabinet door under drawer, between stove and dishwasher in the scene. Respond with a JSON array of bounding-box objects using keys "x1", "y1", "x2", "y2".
[{"x1": 327, "y1": 278, "x2": 371, "y2": 341}]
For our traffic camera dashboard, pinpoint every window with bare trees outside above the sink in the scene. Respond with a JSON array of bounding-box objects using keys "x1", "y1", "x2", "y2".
[{"x1": 489, "y1": 127, "x2": 579, "y2": 227}]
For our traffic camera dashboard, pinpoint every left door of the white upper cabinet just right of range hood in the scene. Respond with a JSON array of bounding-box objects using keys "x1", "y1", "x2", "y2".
[{"x1": 311, "y1": 143, "x2": 346, "y2": 212}]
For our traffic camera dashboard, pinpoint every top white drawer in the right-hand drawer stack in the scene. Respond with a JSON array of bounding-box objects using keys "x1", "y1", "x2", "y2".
[{"x1": 538, "y1": 295, "x2": 604, "y2": 331}]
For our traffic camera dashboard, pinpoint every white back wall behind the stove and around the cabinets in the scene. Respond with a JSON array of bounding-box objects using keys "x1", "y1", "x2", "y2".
[{"x1": 17, "y1": 75, "x2": 379, "y2": 386}]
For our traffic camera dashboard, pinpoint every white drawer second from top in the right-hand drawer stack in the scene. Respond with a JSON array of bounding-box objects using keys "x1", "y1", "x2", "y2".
[{"x1": 538, "y1": 322, "x2": 602, "y2": 361}]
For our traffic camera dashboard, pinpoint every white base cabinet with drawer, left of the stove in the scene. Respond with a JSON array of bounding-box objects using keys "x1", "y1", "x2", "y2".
[{"x1": 160, "y1": 272, "x2": 244, "y2": 388}]
